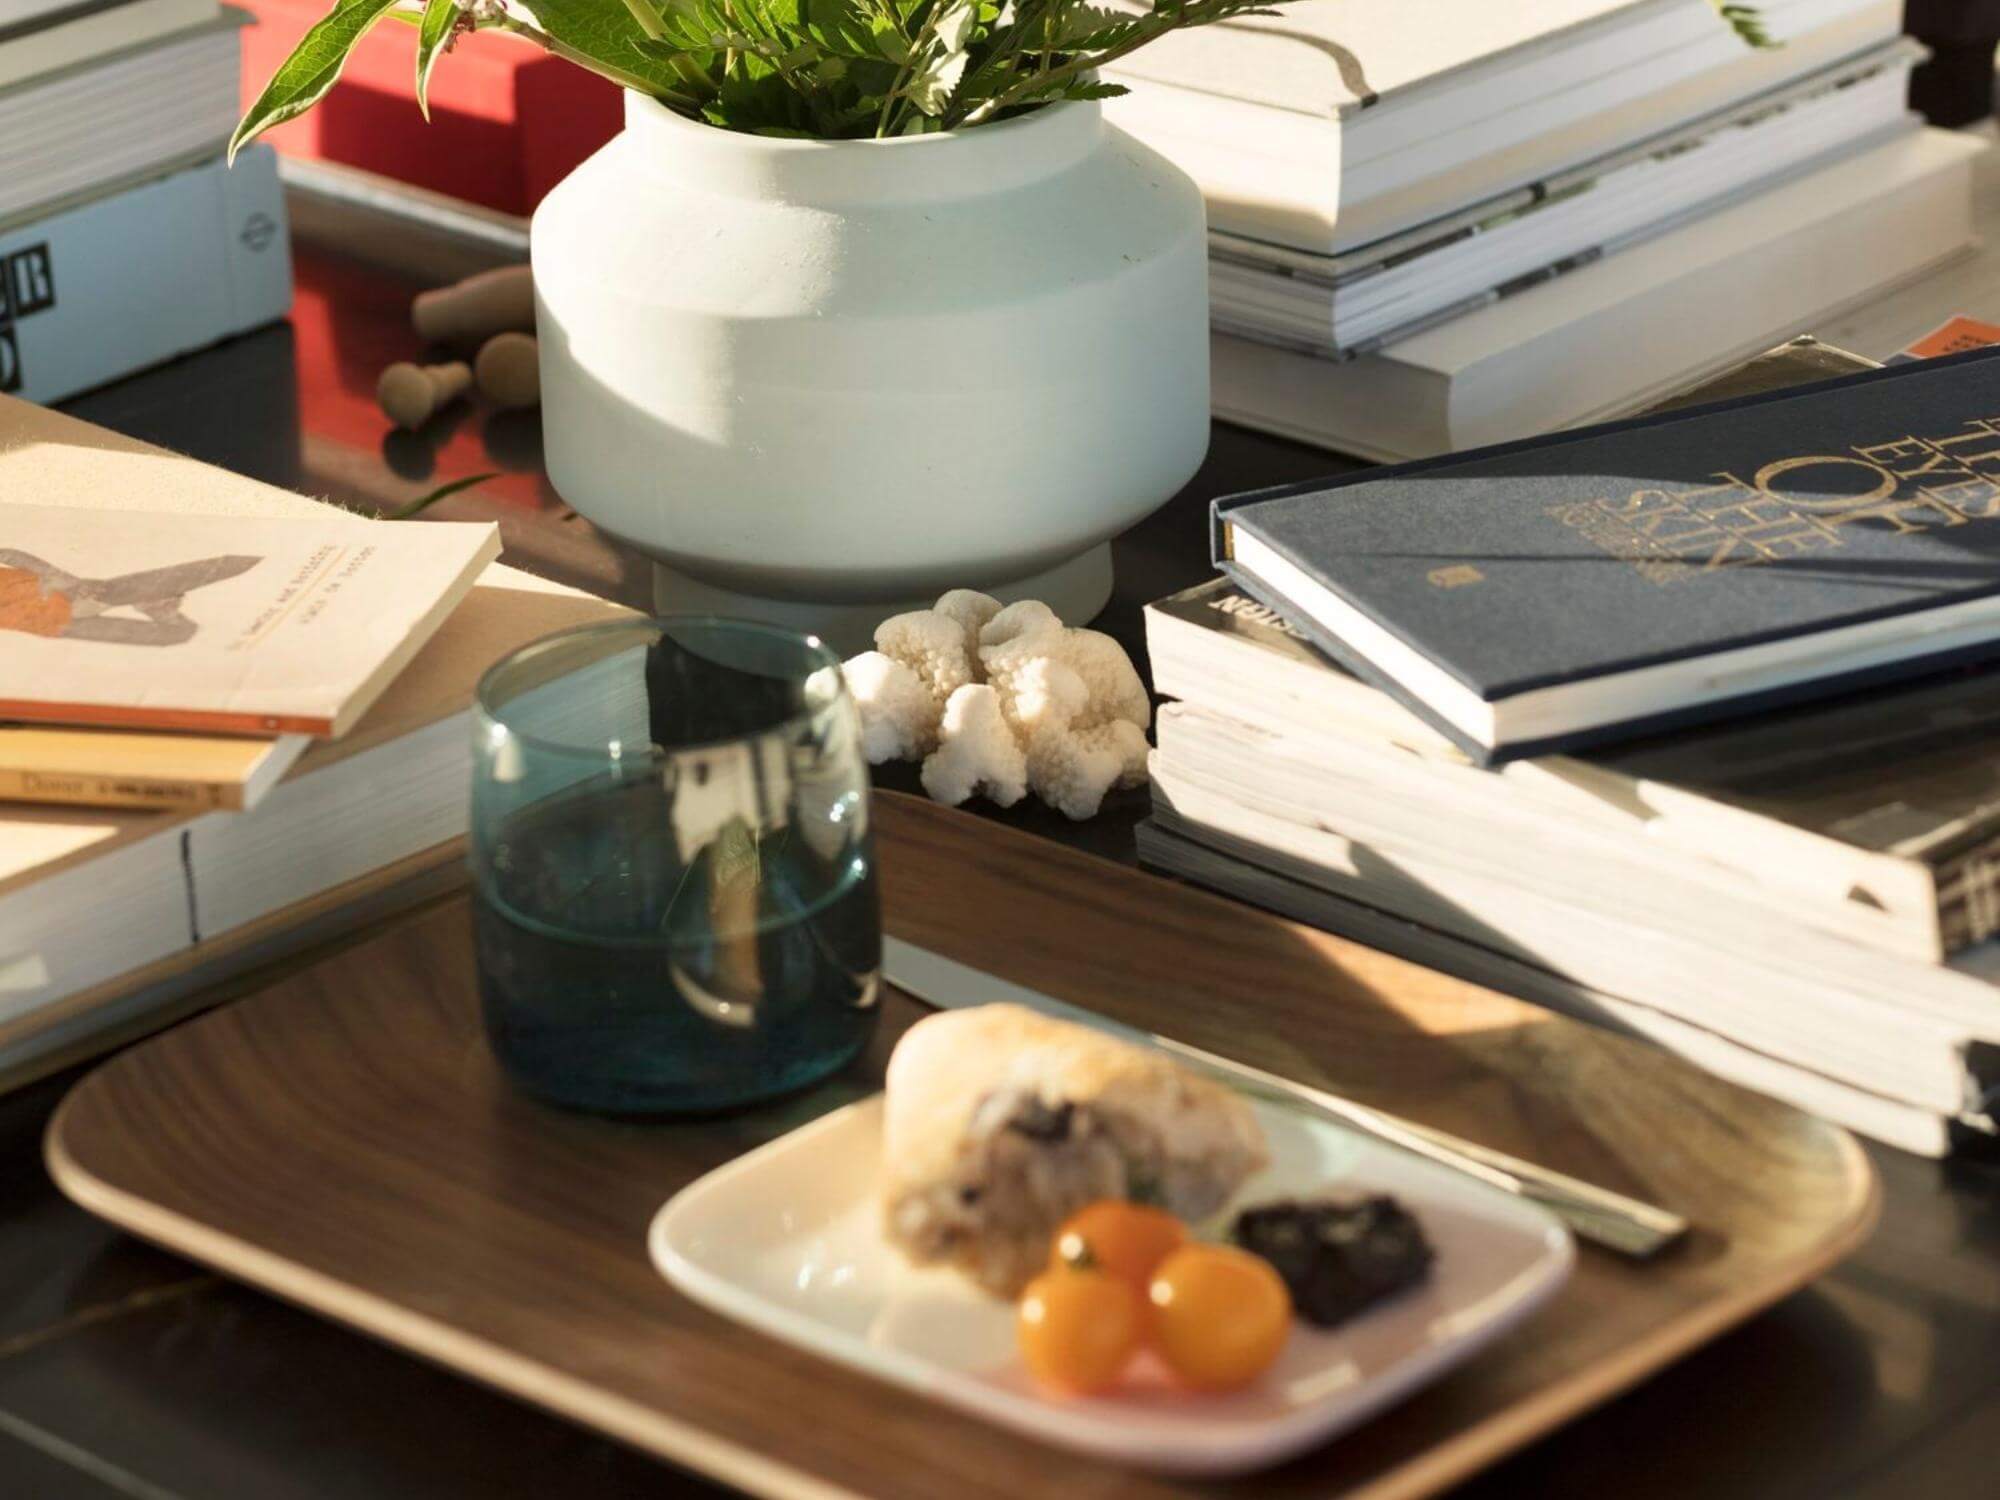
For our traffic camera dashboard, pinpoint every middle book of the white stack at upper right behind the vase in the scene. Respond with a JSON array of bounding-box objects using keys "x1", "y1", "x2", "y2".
[{"x1": 1208, "y1": 40, "x2": 1926, "y2": 354}]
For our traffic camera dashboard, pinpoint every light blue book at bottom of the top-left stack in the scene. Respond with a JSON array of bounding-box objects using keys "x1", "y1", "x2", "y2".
[{"x1": 0, "y1": 146, "x2": 292, "y2": 402}]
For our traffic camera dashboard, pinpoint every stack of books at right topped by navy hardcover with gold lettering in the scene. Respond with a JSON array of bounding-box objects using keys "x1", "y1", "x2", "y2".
[{"x1": 1140, "y1": 348, "x2": 2000, "y2": 1154}]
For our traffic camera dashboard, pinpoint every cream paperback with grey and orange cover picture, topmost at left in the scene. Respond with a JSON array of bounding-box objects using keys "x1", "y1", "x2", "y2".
[{"x1": 0, "y1": 502, "x2": 500, "y2": 738}]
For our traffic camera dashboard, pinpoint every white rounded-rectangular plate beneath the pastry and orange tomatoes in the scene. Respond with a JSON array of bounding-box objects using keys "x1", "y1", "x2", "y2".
[{"x1": 648, "y1": 1094, "x2": 1574, "y2": 1474}]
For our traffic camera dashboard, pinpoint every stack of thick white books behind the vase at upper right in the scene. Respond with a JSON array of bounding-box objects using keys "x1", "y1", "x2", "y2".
[{"x1": 1108, "y1": 0, "x2": 1980, "y2": 460}]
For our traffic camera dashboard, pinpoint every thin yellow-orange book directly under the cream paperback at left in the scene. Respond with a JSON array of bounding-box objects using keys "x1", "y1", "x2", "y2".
[{"x1": 0, "y1": 724, "x2": 312, "y2": 812}]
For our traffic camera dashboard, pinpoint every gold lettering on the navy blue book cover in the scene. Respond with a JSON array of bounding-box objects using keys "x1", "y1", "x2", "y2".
[{"x1": 1546, "y1": 418, "x2": 2000, "y2": 586}]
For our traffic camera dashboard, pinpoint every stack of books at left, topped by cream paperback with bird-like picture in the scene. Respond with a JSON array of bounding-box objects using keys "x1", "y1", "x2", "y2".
[{"x1": 0, "y1": 388, "x2": 618, "y2": 1088}]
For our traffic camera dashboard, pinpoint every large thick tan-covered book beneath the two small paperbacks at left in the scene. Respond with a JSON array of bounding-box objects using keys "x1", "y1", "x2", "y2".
[{"x1": 0, "y1": 396, "x2": 624, "y2": 1088}]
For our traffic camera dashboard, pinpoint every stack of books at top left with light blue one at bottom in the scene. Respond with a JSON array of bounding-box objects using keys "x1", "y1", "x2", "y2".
[{"x1": 0, "y1": 0, "x2": 292, "y2": 402}]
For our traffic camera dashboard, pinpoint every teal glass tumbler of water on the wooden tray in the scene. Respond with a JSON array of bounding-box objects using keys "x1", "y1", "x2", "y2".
[{"x1": 472, "y1": 620, "x2": 882, "y2": 1114}]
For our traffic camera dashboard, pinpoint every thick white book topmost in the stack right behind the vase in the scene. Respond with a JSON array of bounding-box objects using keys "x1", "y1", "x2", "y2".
[{"x1": 1106, "y1": 0, "x2": 1902, "y2": 252}]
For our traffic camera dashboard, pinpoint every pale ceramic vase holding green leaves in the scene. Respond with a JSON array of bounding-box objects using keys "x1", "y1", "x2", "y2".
[{"x1": 534, "y1": 94, "x2": 1208, "y2": 646}]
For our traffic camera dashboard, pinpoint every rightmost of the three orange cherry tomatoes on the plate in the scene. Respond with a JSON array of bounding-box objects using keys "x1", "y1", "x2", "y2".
[{"x1": 1148, "y1": 1244, "x2": 1292, "y2": 1390}]
